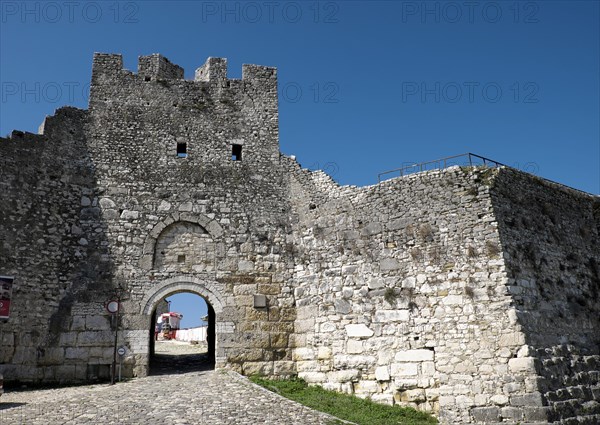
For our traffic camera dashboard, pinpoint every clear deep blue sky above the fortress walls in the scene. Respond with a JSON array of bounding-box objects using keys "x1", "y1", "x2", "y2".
[{"x1": 0, "y1": 0, "x2": 600, "y2": 328}]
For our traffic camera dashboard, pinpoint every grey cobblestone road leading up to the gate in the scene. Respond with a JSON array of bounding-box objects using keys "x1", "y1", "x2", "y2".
[{"x1": 0, "y1": 342, "x2": 332, "y2": 425}]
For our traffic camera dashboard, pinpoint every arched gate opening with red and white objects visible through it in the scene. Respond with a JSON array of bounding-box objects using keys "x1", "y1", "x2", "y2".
[{"x1": 149, "y1": 292, "x2": 215, "y2": 375}]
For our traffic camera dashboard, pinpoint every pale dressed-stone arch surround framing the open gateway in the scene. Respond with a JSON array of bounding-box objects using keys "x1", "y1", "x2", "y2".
[{"x1": 140, "y1": 276, "x2": 225, "y2": 366}]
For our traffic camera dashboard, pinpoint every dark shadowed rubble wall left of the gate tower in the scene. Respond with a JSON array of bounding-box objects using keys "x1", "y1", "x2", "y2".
[{"x1": 0, "y1": 108, "x2": 119, "y2": 382}]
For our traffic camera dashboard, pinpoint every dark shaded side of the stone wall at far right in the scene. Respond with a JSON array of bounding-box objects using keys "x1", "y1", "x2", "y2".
[{"x1": 492, "y1": 170, "x2": 600, "y2": 424}]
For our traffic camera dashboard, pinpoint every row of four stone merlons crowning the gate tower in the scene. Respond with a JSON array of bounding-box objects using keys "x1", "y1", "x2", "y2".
[{"x1": 92, "y1": 53, "x2": 277, "y2": 83}]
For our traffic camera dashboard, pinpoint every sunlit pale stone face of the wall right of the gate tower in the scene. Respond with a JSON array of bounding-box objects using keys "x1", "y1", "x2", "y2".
[{"x1": 288, "y1": 168, "x2": 516, "y2": 422}]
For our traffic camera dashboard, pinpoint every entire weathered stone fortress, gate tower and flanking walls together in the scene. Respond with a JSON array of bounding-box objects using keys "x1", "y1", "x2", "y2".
[{"x1": 0, "y1": 54, "x2": 600, "y2": 424}]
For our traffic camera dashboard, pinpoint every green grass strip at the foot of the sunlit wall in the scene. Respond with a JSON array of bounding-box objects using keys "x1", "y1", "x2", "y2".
[{"x1": 250, "y1": 376, "x2": 437, "y2": 425}]
